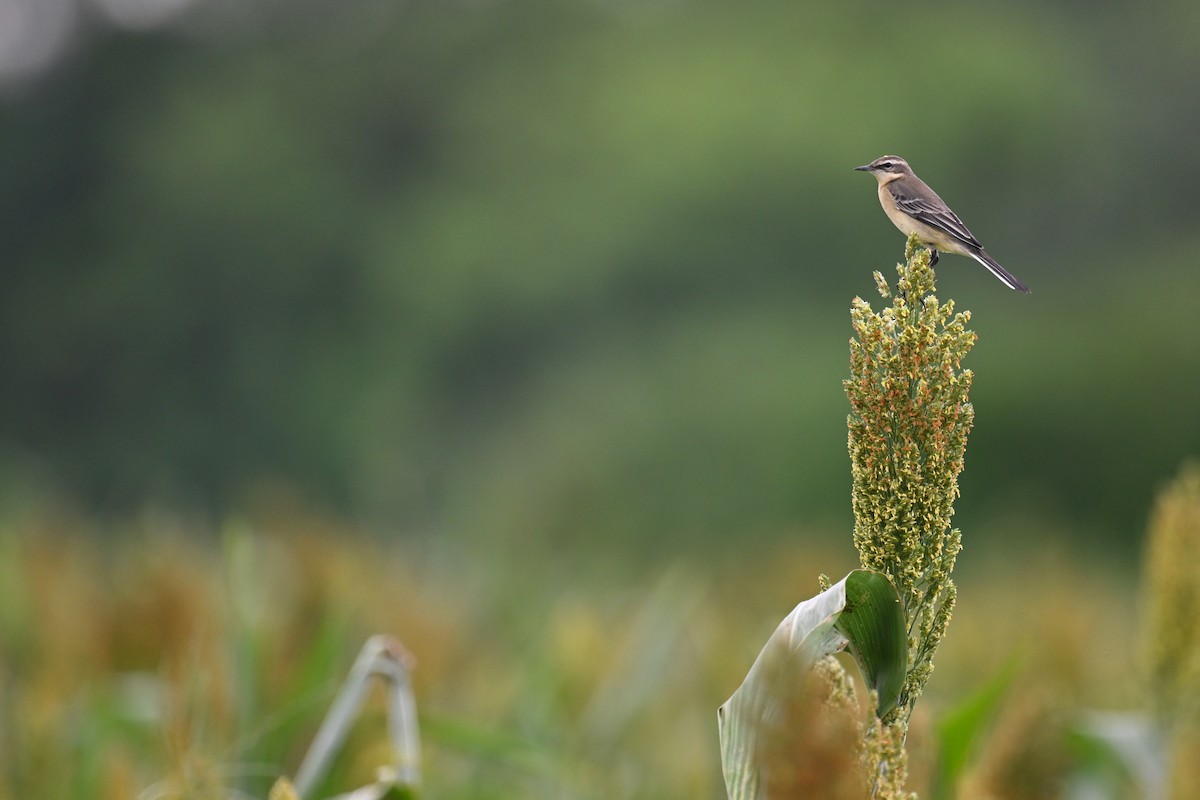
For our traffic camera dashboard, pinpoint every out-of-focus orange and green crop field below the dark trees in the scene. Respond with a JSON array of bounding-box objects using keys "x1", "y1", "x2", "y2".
[{"x1": 0, "y1": 505, "x2": 1141, "y2": 800}]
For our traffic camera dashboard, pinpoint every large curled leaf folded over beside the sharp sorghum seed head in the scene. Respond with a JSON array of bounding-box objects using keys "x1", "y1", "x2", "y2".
[{"x1": 716, "y1": 570, "x2": 908, "y2": 800}]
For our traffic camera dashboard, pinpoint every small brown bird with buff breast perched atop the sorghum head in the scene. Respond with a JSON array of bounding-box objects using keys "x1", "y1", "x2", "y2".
[{"x1": 854, "y1": 156, "x2": 1030, "y2": 294}]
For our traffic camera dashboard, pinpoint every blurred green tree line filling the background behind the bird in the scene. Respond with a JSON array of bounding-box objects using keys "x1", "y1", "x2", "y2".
[{"x1": 0, "y1": 0, "x2": 1200, "y2": 547}]
